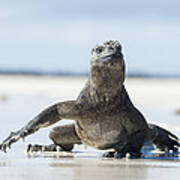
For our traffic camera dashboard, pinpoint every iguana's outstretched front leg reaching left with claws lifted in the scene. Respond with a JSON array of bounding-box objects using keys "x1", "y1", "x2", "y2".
[{"x1": 0, "y1": 101, "x2": 79, "y2": 152}]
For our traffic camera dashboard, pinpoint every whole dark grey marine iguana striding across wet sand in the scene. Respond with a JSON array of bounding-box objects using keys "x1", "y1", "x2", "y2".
[{"x1": 0, "y1": 40, "x2": 180, "y2": 158}]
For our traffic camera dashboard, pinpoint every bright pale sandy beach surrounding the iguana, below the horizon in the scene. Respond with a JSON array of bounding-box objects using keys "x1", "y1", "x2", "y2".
[{"x1": 0, "y1": 76, "x2": 180, "y2": 180}]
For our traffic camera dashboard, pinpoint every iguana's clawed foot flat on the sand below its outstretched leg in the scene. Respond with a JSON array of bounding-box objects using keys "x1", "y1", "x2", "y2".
[{"x1": 27, "y1": 144, "x2": 64, "y2": 153}]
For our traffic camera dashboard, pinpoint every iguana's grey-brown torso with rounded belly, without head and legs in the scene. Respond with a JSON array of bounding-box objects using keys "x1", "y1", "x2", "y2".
[{"x1": 75, "y1": 84, "x2": 148, "y2": 149}]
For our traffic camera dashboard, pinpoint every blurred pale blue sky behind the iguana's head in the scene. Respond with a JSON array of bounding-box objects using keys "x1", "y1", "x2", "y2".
[{"x1": 0, "y1": 0, "x2": 180, "y2": 76}]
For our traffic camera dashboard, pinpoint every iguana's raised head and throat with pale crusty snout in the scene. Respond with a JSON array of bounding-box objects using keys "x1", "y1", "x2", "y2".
[{"x1": 90, "y1": 40, "x2": 125, "y2": 89}]
